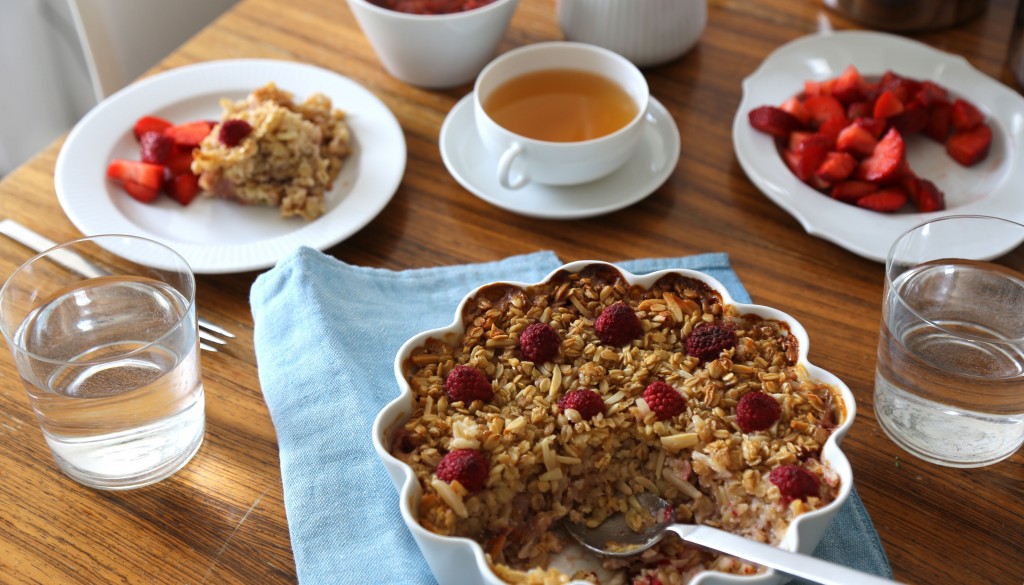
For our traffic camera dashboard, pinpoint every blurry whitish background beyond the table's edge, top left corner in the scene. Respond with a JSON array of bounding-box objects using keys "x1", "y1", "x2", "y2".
[{"x1": 0, "y1": 0, "x2": 237, "y2": 176}]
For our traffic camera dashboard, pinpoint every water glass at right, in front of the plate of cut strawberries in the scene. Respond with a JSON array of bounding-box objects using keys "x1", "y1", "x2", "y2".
[{"x1": 874, "y1": 215, "x2": 1024, "y2": 467}]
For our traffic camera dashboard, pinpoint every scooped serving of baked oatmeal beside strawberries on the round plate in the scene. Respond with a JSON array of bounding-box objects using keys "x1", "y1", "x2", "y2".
[{"x1": 191, "y1": 83, "x2": 350, "y2": 219}]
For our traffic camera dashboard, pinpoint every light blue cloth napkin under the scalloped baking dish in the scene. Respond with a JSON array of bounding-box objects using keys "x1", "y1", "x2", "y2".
[{"x1": 250, "y1": 248, "x2": 892, "y2": 585}]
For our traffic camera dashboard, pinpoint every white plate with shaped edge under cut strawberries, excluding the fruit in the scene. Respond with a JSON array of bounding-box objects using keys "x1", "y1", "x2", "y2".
[{"x1": 732, "y1": 31, "x2": 1024, "y2": 262}]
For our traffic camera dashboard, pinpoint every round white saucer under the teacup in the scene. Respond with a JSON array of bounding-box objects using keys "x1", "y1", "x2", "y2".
[{"x1": 440, "y1": 93, "x2": 679, "y2": 219}]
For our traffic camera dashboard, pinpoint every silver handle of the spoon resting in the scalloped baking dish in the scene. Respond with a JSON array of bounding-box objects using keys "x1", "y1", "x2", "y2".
[{"x1": 667, "y1": 524, "x2": 893, "y2": 585}]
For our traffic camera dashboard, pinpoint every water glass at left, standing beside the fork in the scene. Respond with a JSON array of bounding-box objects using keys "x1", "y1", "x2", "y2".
[{"x1": 0, "y1": 236, "x2": 206, "y2": 490}]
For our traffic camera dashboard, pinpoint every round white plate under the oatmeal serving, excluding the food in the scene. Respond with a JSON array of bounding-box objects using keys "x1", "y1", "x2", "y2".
[{"x1": 54, "y1": 59, "x2": 406, "y2": 274}]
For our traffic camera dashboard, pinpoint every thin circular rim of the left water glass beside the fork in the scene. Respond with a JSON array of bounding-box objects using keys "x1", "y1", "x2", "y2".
[{"x1": 0, "y1": 234, "x2": 199, "y2": 366}]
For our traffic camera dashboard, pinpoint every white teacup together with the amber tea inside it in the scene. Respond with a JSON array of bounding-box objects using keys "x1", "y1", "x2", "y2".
[{"x1": 473, "y1": 42, "x2": 650, "y2": 189}]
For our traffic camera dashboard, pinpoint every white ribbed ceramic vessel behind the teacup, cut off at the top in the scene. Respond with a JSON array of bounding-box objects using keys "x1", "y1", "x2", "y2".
[{"x1": 557, "y1": 0, "x2": 708, "y2": 67}]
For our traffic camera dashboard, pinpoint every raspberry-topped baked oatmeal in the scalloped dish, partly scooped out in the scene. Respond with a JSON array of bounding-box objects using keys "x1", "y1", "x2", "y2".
[{"x1": 390, "y1": 264, "x2": 846, "y2": 584}]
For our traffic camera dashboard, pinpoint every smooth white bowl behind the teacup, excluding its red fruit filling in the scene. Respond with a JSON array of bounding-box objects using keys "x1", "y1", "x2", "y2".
[{"x1": 348, "y1": 0, "x2": 519, "y2": 89}]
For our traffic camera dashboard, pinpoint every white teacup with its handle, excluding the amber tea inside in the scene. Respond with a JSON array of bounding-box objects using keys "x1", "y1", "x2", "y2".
[{"x1": 473, "y1": 42, "x2": 650, "y2": 189}]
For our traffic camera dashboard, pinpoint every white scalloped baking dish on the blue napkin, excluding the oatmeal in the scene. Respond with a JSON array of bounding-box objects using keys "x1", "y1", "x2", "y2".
[{"x1": 373, "y1": 260, "x2": 856, "y2": 585}]
